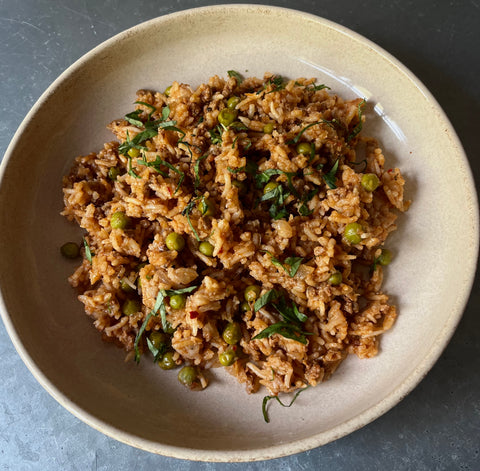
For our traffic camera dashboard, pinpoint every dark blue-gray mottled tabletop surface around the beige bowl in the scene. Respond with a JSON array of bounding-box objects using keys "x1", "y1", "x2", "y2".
[{"x1": 0, "y1": 0, "x2": 480, "y2": 471}]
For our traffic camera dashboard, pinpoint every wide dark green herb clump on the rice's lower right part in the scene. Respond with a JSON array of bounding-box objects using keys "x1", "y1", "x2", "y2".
[{"x1": 252, "y1": 290, "x2": 313, "y2": 345}]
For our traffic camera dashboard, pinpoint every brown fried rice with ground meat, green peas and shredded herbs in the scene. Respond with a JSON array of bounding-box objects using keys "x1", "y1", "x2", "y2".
[{"x1": 62, "y1": 71, "x2": 409, "y2": 402}]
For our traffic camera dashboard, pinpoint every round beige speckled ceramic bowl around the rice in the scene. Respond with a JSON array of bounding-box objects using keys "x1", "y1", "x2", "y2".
[{"x1": 0, "y1": 5, "x2": 478, "y2": 461}]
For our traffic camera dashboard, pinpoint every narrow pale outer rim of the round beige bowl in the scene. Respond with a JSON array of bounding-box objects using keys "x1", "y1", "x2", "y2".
[{"x1": 0, "y1": 3, "x2": 479, "y2": 462}]
